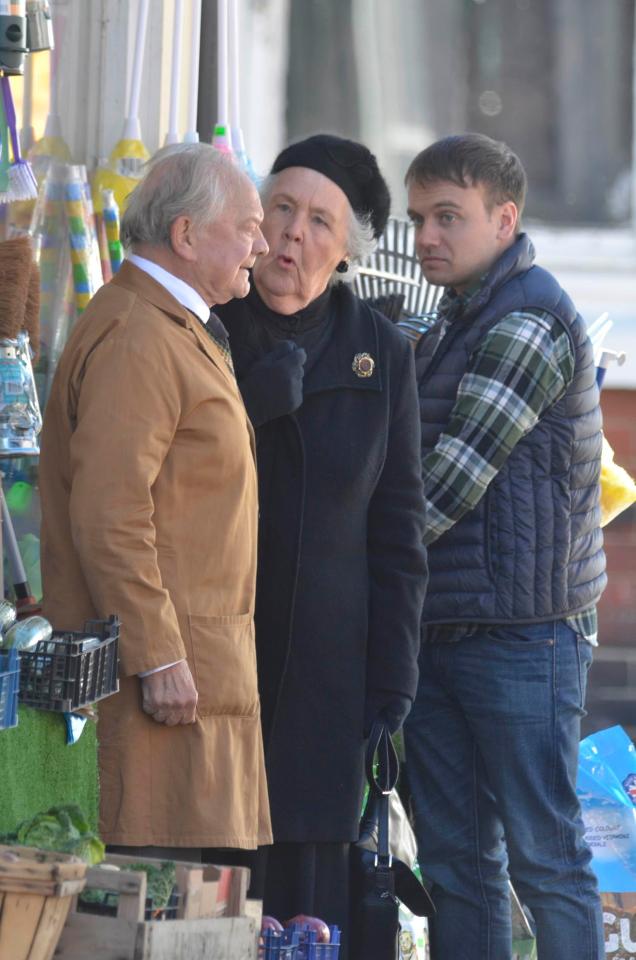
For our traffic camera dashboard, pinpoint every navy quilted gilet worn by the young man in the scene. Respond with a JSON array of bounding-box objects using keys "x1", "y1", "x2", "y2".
[{"x1": 416, "y1": 234, "x2": 606, "y2": 623}]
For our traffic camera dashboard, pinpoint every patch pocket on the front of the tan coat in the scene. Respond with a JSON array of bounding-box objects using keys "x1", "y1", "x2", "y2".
[{"x1": 188, "y1": 613, "x2": 258, "y2": 717}]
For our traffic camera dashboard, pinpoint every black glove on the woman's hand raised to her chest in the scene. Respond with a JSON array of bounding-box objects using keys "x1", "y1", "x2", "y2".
[{"x1": 239, "y1": 340, "x2": 307, "y2": 427}]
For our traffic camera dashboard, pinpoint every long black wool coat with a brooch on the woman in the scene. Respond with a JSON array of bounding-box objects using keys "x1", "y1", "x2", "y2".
[{"x1": 218, "y1": 284, "x2": 427, "y2": 842}]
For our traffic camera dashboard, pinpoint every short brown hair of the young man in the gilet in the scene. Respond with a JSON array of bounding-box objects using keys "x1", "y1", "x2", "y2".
[{"x1": 404, "y1": 133, "x2": 528, "y2": 219}]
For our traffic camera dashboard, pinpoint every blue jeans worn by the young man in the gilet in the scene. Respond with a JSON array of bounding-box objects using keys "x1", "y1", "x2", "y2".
[{"x1": 404, "y1": 621, "x2": 605, "y2": 960}]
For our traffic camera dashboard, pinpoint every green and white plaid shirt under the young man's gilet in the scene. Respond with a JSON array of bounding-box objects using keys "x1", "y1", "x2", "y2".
[{"x1": 422, "y1": 290, "x2": 597, "y2": 643}]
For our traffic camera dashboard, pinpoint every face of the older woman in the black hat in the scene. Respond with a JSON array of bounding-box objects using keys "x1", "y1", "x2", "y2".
[{"x1": 254, "y1": 167, "x2": 351, "y2": 314}]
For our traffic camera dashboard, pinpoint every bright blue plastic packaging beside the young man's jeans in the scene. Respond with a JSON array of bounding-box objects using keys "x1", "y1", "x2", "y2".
[{"x1": 577, "y1": 727, "x2": 636, "y2": 893}]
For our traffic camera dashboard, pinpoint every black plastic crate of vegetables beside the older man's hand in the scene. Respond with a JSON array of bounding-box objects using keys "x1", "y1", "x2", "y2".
[{"x1": 20, "y1": 617, "x2": 120, "y2": 713}]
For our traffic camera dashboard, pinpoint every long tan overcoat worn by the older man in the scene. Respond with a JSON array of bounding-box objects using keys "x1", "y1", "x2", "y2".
[{"x1": 40, "y1": 263, "x2": 271, "y2": 848}]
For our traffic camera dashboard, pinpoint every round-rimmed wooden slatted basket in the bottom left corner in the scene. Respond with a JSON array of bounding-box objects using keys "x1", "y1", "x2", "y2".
[{"x1": 0, "y1": 846, "x2": 86, "y2": 960}]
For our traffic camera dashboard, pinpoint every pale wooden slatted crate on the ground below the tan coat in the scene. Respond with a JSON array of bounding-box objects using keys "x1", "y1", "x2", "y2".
[{"x1": 54, "y1": 855, "x2": 260, "y2": 960}]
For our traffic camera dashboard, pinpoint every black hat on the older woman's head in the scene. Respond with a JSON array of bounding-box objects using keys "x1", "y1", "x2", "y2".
[{"x1": 271, "y1": 133, "x2": 391, "y2": 239}]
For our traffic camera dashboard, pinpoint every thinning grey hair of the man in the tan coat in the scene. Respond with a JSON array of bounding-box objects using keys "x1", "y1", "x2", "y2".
[{"x1": 121, "y1": 143, "x2": 247, "y2": 247}]
